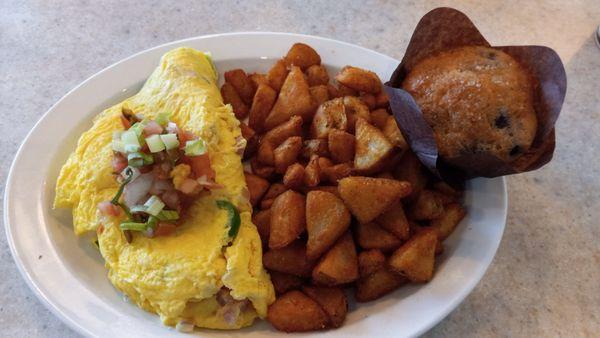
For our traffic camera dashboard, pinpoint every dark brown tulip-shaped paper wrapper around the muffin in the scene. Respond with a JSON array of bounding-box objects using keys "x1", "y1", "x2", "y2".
[{"x1": 385, "y1": 7, "x2": 567, "y2": 183}]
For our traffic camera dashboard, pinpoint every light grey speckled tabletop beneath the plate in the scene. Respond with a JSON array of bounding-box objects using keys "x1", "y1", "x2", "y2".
[{"x1": 0, "y1": 0, "x2": 600, "y2": 337}]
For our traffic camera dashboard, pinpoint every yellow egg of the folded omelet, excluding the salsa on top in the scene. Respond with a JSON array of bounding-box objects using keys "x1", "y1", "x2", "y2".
[{"x1": 54, "y1": 48, "x2": 275, "y2": 329}]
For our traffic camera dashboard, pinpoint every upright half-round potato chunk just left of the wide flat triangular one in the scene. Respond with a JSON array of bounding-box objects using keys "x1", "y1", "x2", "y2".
[{"x1": 306, "y1": 191, "x2": 350, "y2": 259}]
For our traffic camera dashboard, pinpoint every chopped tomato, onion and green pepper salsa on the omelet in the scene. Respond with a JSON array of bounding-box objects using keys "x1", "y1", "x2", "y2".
[{"x1": 98, "y1": 108, "x2": 221, "y2": 237}]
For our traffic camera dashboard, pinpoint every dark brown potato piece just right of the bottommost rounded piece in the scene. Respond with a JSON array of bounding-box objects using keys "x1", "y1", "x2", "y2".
[{"x1": 302, "y1": 286, "x2": 348, "y2": 327}]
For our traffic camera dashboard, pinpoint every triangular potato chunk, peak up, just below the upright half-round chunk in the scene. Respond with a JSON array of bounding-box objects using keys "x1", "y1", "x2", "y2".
[{"x1": 312, "y1": 232, "x2": 358, "y2": 286}]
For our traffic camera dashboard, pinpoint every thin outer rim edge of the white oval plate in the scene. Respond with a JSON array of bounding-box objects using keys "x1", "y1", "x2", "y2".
[{"x1": 3, "y1": 31, "x2": 508, "y2": 336}]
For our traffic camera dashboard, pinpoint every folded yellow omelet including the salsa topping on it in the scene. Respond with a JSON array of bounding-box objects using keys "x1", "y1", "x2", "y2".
[{"x1": 54, "y1": 48, "x2": 275, "y2": 329}]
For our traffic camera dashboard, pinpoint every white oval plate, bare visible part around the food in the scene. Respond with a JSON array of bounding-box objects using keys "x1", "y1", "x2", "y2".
[{"x1": 4, "y1": 33, "x2": 507, "y2": 337}]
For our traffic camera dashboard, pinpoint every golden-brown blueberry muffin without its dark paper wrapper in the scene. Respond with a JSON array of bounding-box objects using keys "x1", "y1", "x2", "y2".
[{"x1": 402, "y1": 46, "x2": 537, "y2": 161}]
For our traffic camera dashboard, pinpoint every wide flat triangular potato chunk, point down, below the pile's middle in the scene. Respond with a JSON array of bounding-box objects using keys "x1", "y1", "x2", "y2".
[{"x1": 338, "y1": 176, "x2": 411, "y2": 223}]
